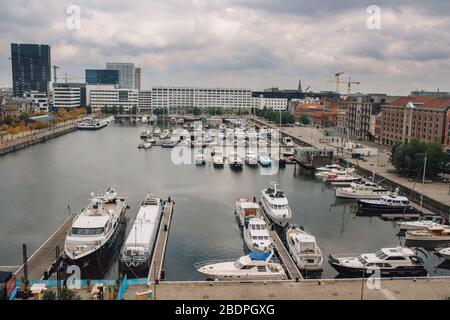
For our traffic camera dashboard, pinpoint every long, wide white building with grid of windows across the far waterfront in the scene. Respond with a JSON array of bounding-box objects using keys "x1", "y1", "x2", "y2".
[{"x1": 152, "y1": 87, "x2": 252, "y2": 113}]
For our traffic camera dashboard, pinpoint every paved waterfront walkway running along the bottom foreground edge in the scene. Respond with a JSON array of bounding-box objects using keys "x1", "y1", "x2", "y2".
[{"x1": 124, "y1": 277, "x2": 450, "y2": 300}]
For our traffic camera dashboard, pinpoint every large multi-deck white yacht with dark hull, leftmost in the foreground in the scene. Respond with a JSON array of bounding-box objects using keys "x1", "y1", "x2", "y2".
[{"x1": 64, "y1": 188, "x2": 127, "y2": 268}]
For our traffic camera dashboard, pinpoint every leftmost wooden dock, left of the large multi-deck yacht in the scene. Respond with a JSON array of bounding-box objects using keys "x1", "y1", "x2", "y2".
[{"x1": 15, "y1": 216, "x2": 73, "y2": 280}]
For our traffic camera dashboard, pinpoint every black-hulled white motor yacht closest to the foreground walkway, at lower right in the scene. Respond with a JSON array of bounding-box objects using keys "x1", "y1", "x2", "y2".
[{"x1": 328, "y1": 247, "x2": 427, "y2": 277}]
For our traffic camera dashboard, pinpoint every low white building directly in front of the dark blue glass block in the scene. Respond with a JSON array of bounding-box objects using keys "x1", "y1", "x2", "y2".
[{"x1": 86, "y1": 85, "x2": 139, "y2": 111}]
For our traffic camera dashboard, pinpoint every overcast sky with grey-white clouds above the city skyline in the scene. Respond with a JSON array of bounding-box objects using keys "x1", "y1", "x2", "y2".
[{"x1": 0, "y1": 0, "x2": 450, "y2": 94}]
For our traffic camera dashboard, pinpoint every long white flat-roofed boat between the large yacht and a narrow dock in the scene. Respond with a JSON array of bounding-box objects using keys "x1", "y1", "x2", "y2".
[{"x1": 120, "y1": 194, "x2": 163, "y2": 276}]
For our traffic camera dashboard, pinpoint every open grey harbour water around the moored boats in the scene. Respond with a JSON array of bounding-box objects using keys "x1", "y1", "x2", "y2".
[{"x1": 0, "y1": 125, "x2": 450, "y2": 280}]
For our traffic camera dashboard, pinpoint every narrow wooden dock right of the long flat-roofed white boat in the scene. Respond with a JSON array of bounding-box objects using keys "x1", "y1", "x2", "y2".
[{"x1": 147, "y1": 198, "x2": 175, "y2": 284}]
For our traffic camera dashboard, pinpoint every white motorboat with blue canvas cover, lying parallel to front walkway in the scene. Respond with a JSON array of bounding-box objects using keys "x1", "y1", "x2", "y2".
[{"x1": 196, "y1": 251, "x2": 287, "y2": 281}]
